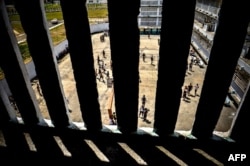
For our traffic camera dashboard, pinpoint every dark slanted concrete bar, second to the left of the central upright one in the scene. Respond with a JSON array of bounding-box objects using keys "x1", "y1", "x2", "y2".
[{"x1": 14, "y1": 0, "x2": 69, "y2": 127}]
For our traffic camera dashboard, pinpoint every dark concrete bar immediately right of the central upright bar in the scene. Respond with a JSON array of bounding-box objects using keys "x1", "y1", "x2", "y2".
[{"x1": 154, "y1": 0, "x2": 196, "y2": 135}]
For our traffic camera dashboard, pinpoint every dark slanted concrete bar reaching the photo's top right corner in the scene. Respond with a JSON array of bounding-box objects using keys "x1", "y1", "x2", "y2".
[{"x1": 192, "y1": 0, "x2": 250, "y2": 138}]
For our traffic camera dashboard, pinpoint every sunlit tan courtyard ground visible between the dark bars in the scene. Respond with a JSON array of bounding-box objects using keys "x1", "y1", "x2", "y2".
[{"x1": 33, "y1": 34, "x2": 236, "y2": 135}]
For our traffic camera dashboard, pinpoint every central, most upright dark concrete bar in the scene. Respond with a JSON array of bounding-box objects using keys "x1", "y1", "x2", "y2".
[{"x1": 108, "y1": 0, "x2": 140, "y2": 133}]
